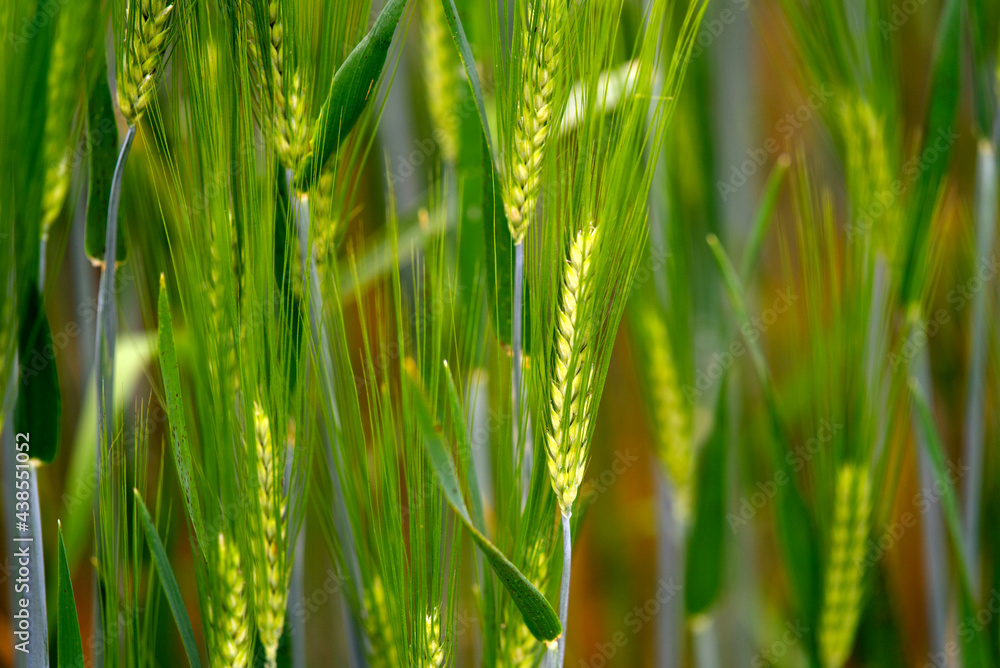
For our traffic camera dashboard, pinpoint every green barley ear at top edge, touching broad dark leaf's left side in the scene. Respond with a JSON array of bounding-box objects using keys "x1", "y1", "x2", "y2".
[{"x1": 267, "y1": 0, "x2": 309, "y2": 172}]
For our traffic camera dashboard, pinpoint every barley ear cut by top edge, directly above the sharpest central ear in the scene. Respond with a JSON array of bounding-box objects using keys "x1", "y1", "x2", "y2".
[{"x1": 503, "y1": 0, "x2": 565, "y2": 244}]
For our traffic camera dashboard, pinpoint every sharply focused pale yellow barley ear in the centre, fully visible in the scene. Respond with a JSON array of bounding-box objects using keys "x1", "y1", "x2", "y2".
[{"x1": 545, "y1": 225, "x2": 596, "y2": 514}]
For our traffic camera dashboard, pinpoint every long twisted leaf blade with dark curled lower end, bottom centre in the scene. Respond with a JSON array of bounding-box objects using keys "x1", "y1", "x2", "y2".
[{"x1": 407, "y1": 365, "x2": 562, "y2": 642}]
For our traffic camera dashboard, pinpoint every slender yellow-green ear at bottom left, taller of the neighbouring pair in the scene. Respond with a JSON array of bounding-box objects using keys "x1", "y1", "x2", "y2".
[{"x1": 254, "y1": 403, "x2": 289, "y2": 668}]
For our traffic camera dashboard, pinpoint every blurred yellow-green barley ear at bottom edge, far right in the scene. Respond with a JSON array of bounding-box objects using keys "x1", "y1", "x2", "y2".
[{"x1": 819, "y1": 464, "x2": 871, "y2": 668}]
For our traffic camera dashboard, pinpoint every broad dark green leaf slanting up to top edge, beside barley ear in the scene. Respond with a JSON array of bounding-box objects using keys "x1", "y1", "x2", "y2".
[{"x1": 295, "y1": 0, "x2": 406, "y2": 191}]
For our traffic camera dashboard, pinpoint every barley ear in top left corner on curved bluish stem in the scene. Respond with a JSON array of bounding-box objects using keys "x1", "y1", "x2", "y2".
[{"x1": 118, "y1": 0, "x2": 175, "y2": 127}]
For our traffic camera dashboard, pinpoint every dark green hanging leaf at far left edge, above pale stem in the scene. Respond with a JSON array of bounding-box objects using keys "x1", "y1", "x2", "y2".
[{"x1": 14, "y1": 285, "x2": 62, "y2": 464}]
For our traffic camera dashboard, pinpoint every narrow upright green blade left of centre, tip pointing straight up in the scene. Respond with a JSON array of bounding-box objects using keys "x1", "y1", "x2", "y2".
[{"x1": 159, "y1": 274, "x2": 208, "y2": 555}]
